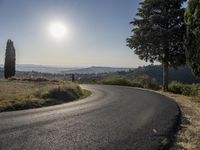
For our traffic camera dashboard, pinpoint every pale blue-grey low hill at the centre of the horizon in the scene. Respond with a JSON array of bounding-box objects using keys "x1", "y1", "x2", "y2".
[{"x1": 62, "y1": 66, "x2": 130, "y2": 74}]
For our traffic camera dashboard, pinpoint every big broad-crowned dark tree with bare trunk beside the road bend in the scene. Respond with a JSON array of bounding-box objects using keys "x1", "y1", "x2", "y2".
[{"x1": 127, "y1": 0, "x2": 186, "y2": 91}]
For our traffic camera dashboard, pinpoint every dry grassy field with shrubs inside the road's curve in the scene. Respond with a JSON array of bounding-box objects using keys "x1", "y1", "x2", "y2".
[{"x1": 0, "y1": 78, "x2": 90, "y2": 112}]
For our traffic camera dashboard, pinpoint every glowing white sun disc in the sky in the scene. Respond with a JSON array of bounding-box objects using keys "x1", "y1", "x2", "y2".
[{"x1": 49, "y1": 22, "x2": 67, "y2": 39}]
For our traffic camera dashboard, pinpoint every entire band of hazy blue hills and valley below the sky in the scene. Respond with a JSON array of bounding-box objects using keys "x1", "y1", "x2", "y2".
[{"x1": 0, "y1": 65, "x2": 200, "y2": 84}]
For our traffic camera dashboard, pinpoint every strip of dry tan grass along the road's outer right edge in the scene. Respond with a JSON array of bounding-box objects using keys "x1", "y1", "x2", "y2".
[{"x1": 160, "y1": 92, "x2": 200, "y2": 150}]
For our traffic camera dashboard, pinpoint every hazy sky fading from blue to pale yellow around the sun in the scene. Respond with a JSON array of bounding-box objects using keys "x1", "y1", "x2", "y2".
[{"x1": 0, "y1": 0, "x2": 151, "y2": 67}]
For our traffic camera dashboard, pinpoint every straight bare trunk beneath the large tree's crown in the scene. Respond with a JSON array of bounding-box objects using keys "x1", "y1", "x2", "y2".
[{"x1": 163, "y1": 61, "x2": 169, "y2": 91}]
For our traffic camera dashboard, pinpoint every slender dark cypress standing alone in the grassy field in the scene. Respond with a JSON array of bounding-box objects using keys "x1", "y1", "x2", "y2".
[{"x1": 4, "y1": 40, "x2": 15, "y2": 79}]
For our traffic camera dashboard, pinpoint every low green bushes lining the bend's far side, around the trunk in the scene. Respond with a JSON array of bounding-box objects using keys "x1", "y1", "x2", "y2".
[{"x1": 98, "y1": 75, "x2": 200, "y2": 102}]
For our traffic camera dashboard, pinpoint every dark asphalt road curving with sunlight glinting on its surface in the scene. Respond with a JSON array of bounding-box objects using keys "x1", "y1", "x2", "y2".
[{"x1": 0, "y1": 85, "x2": 179, "y2": 150}]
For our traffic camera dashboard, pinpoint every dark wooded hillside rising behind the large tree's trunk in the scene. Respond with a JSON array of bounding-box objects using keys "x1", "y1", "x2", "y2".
[{"x1": 76, "y1": 65, "x2": 200, "y2": 84}]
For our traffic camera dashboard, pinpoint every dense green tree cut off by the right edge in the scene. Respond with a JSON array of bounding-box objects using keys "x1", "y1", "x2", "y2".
[{"x1": 185, "y1": 0, "x2": 200, "y2": 77}]
